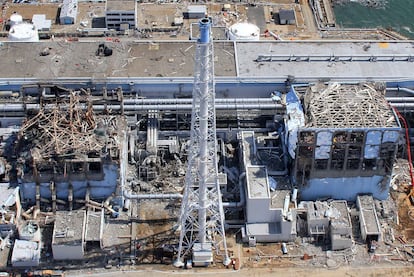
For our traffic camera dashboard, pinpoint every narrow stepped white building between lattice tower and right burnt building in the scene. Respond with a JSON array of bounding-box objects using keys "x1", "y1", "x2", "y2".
[{"x1": 241, "y1": 131, "x2": 296, "y2": 245}]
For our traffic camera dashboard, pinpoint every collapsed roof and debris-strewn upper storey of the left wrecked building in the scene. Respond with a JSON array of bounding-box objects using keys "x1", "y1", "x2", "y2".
[{"x1": 18, "y1": 91, "x2": 122, "y2": 169}]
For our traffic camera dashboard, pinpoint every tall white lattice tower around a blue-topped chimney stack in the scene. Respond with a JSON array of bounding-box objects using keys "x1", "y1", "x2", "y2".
[{"x1": 174, "y1": 18, "x2": 230, "y2": 267}]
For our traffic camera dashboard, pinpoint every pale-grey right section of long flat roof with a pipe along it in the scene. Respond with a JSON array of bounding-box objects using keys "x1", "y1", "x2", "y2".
[{"x1": 235, "y1": 41, "x2": 414, "y2": 80}]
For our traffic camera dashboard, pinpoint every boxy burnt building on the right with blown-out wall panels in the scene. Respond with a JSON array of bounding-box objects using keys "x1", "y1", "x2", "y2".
[{"x1": 288, "y1": 83, "x2": 401, "y2": 200}]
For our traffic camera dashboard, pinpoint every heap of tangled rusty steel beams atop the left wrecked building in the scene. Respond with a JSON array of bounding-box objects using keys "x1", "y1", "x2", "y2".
[{"x1": 19, "y1": 92, "x2": 106, "y2": 161}]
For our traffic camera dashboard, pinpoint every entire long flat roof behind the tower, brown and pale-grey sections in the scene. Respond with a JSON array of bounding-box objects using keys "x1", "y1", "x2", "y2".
[{"x1": 0, "y1": 41, "x2": 414, "y2": 81}]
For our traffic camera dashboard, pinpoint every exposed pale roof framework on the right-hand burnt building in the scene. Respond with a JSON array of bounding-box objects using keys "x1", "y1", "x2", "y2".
[{"x1": 304, "y1": 83, "x2": 398, "y2": 128}]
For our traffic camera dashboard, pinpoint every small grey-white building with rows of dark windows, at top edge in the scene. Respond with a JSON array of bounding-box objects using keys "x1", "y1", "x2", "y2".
[{"x1": 106, "y1": 0, "x2": 137, "y2": 30}]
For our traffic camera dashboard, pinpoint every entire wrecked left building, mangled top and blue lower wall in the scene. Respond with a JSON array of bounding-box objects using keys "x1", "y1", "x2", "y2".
[{"x1": 16, "y1": 88, "x2": 126, "y2": 211}]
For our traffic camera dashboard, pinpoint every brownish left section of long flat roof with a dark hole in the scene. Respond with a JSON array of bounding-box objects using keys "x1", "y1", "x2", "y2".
[{"x1": 0, "y1": 41, "x2": 236, "y2": 80}]
